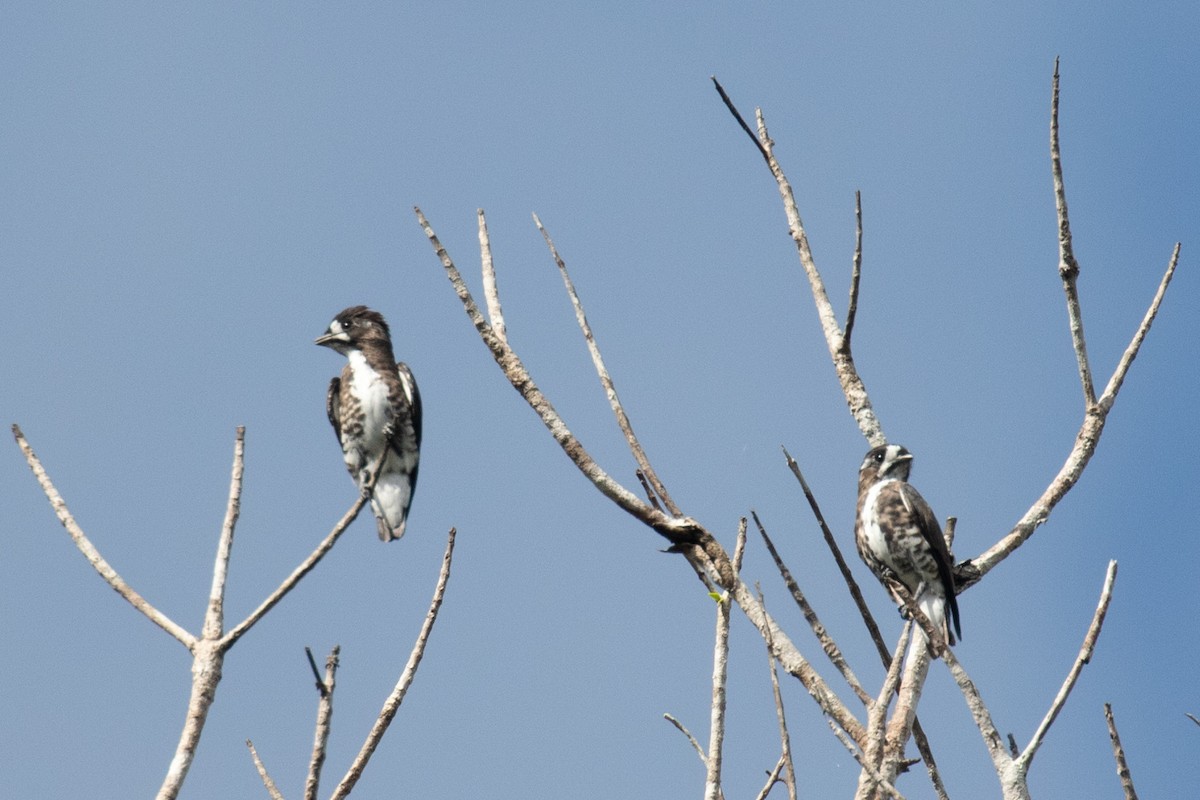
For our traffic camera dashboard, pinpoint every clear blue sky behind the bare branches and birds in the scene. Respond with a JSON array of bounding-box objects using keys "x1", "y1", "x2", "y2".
[{"x1": 0, "y1": 2, "x2": 1200, "y2": 798}]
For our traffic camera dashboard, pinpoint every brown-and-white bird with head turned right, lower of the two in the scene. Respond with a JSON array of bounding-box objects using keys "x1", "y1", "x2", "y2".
[{"x1": 854, "y1": 445, "x2": 962, "y2": 644}]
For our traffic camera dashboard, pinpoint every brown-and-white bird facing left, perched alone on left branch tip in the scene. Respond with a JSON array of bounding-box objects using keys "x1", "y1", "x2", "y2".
[{"x1": 316, "y1": 306, "x2": 421, "y2": 542}]
